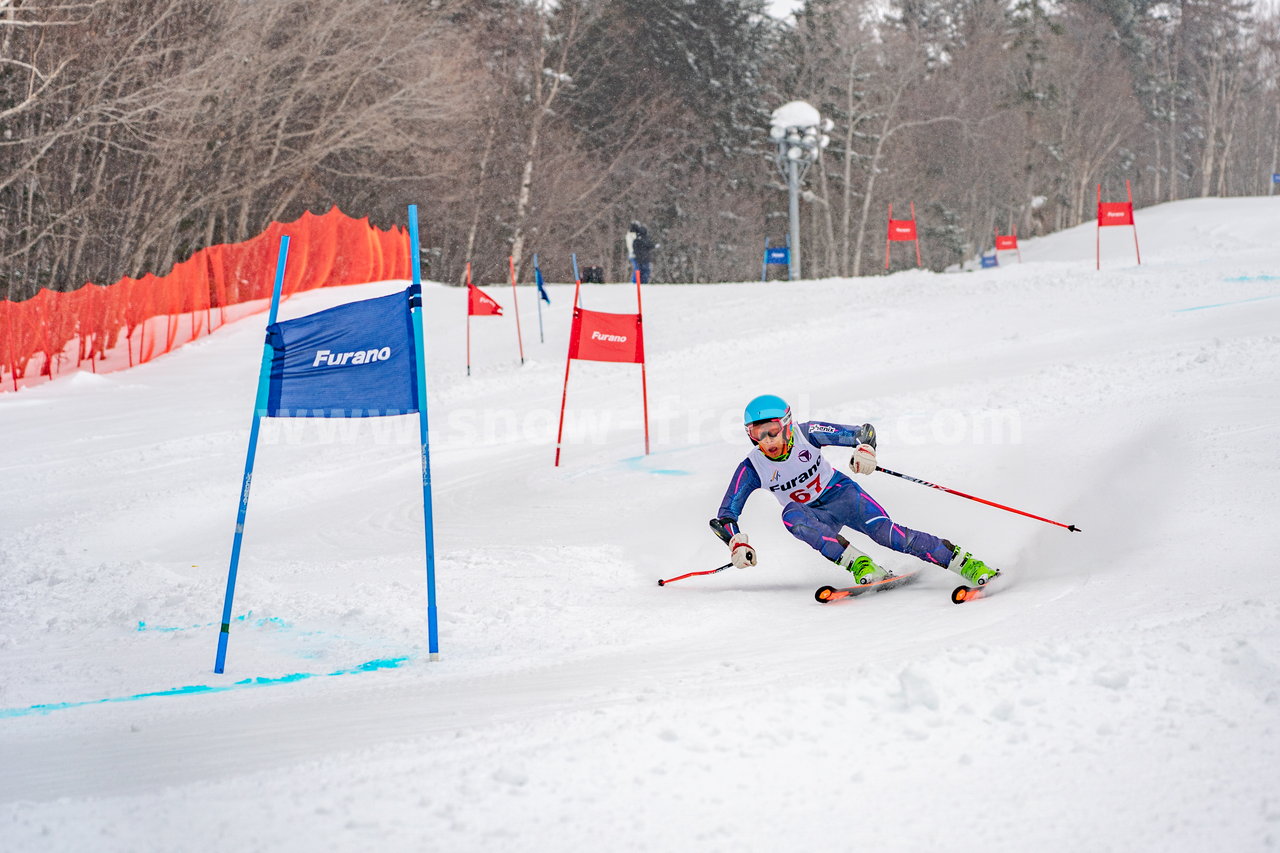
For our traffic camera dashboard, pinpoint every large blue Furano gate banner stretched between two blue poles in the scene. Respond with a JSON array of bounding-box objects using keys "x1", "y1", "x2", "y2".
[{"x1": 265, "y1": 286, "x2": 419, "y2": 418}]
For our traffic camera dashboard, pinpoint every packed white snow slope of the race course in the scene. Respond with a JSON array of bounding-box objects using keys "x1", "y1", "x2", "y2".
[{"x1": 0, "y1": 199, "x2": 1280, "y2": 852}]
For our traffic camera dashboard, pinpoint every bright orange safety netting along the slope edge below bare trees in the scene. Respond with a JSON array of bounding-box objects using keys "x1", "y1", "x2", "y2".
[{"x1": 0, "y1": 207, "x2": 411, "y2": 391}]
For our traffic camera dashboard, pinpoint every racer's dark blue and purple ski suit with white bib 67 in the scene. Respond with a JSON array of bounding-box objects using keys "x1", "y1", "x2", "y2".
[{"x1": 717, "y1": 420, "x2": 952, "y2": 567}]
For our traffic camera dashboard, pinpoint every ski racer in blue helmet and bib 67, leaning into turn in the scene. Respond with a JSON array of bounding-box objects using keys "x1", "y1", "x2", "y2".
[{"x1": 710, "y1": 394, "x2": 1000, "y2": 585}]
